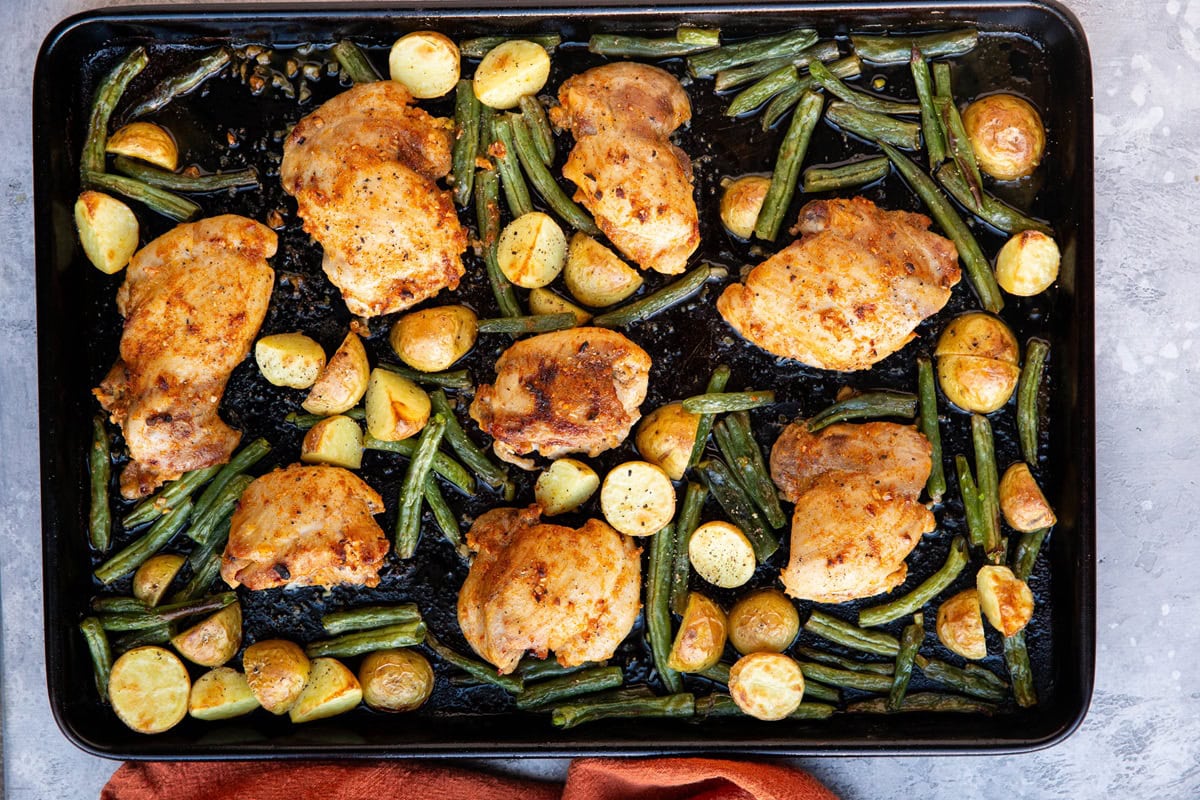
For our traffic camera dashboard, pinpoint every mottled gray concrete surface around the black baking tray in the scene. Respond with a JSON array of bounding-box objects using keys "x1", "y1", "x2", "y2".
[{"x1": 0, "y1": 0, "x2": 1200, "y2": 800}]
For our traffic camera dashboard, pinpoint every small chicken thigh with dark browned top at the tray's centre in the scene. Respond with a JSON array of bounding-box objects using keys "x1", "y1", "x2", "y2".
[{"x1": 470, "y1": 327, "x2": 650, "y2": 469}]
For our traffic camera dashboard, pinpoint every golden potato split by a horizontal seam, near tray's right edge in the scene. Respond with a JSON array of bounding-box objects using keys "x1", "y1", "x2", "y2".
[{"x1": 934, "y1": 311, "x2": 1021, "y2": 414}]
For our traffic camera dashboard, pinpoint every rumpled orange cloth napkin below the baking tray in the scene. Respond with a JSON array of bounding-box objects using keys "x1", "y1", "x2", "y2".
[{"x1": 100, "y1": 758, "x2": 838, "y2": 800}]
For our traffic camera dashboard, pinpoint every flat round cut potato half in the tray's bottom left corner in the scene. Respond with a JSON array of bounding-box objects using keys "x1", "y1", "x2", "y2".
[{"x1": 108, "y1": 646, "x2": 192, "y2": 733}]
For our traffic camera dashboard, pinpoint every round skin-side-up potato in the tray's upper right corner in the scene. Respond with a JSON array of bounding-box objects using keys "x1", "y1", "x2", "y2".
[{"x1": 962, "y1": 94, "x2": 1046, "y2": 181}]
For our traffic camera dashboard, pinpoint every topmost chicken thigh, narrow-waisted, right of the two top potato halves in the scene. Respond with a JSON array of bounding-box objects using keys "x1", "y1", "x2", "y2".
[{"x1": 551, "y1": 62, "x2": 700, "y2": 275}]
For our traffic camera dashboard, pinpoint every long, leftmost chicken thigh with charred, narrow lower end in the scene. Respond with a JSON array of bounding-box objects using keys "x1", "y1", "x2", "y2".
[{"x1": 94, "y1": 215, "x2": 276, "y2": 499}]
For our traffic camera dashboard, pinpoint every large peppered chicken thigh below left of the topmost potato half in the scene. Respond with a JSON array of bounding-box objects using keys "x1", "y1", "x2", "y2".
[{"x1": 280, "y1": 80, "x2": 467, "y2": 317}]
